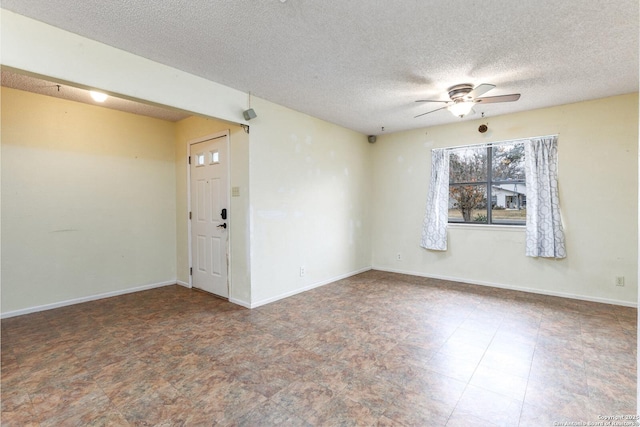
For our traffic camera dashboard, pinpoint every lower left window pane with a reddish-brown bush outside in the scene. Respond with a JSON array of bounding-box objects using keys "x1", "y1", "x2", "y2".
[{"x1": 449, "y1": 184, "x2": 487, "y2": 224}]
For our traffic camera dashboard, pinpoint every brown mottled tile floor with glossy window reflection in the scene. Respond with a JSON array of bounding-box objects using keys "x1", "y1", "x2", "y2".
[{"x1": 1, "y1": 271, "x2": 637, "y2": 427}]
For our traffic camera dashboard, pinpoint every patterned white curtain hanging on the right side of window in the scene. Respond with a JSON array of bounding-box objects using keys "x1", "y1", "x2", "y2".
[{"x1": 524, "y1": 136, "x2": 567, "y2": 258}]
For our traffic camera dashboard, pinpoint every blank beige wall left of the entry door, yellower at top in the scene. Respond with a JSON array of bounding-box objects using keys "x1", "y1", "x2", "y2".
[{"x1": 1, "y1": 88, "x2": 176, "y2": 314}]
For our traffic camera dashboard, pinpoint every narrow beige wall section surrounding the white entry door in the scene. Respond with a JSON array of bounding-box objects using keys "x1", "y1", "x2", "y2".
[{"x1": 175, "y1": 116, "x2": 251, "y2": 306}]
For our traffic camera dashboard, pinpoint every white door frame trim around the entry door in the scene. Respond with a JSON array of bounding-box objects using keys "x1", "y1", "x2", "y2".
[{"x1": 187, "y1": 129, "x2": 233, "y2": 299}]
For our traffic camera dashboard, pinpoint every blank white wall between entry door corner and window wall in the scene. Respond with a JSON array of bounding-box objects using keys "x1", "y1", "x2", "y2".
[{"x1": 250, "y1": 99, "x2": 371, "y2": 306}]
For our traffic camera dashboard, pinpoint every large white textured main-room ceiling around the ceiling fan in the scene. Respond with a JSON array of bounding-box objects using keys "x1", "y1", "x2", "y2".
[{"x1": 2, "y1": 0, "x2": 639, "y2": 134}]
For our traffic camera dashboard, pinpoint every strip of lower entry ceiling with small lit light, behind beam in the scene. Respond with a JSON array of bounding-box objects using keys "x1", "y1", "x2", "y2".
[{"x1": 0, "y1": 70, "x2": 192, "y2": 122}]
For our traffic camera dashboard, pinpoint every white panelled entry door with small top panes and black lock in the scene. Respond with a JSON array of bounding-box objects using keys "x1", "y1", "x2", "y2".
[{"x1": 190, "y1": 135, "x2": 229, "y2": 298}]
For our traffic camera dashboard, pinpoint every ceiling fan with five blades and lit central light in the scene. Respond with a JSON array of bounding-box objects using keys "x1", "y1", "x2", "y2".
[{"x1": 416, "y1": 83, "x2": 520, "y2": 118}]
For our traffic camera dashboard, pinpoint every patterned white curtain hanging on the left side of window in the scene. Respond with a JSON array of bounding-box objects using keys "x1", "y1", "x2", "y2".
[{"x1": 420, "y1": 149, "x2": 449, "y2": 251}]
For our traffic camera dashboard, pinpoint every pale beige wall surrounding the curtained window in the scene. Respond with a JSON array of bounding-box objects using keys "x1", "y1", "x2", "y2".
[{"x1": 372, "y1": 94, "x2": 638, "y2": 304}]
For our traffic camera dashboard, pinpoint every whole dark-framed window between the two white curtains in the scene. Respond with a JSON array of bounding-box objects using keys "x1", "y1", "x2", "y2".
[{"x1": 449, "y1": 142, "x2": 527, "y2": 225}]
